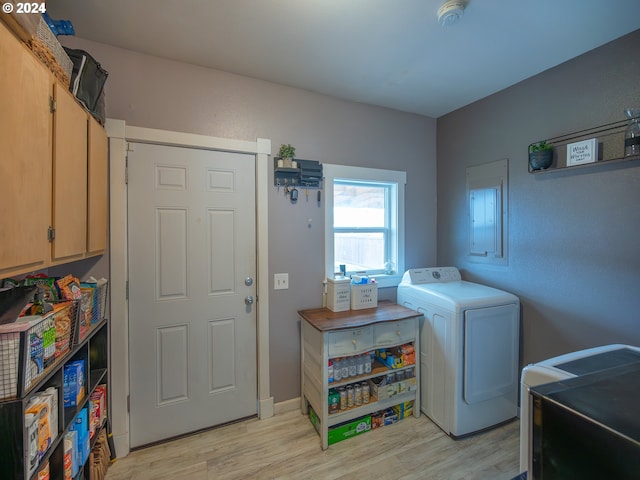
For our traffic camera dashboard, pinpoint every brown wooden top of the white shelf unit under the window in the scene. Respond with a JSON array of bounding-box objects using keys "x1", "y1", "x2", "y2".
[{"x1": 298, "y1": 300, "x2": 422, "y2": 332}]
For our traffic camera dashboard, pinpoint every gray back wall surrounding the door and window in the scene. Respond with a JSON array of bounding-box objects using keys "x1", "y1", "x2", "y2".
[{"x1": 61, "y1": 37, "x2": 436, "y2": 402}]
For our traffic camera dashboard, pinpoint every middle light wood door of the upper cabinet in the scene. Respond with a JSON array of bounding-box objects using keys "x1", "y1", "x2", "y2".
[{"x1": 51, "y1": 83, "x2": 87, "y2": 261}]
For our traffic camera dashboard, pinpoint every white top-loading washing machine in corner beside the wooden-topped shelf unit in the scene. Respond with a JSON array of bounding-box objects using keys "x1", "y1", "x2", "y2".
[{"x1": 397, "y1": 267, "x2": 520, "y2": 438}]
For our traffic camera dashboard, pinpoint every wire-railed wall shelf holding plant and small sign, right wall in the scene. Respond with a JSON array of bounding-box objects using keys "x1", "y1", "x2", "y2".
[{"x1": 527, "y1": 120, "x2": 640, "y2": 175}]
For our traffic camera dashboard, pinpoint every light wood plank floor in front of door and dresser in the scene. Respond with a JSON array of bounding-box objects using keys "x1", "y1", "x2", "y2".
[{"x1": 106, "y1": 411, "x2": 519, "y2": 480}]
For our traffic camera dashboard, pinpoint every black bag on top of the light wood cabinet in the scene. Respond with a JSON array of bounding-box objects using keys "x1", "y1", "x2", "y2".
[{"x1": 64, "y1": 47, "x2": 109, "y2": 124}]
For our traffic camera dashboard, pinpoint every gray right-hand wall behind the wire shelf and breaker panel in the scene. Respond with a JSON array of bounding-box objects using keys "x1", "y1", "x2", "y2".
[{"x1": 437, "y1": 30, "x2": 640, "y2": 364}]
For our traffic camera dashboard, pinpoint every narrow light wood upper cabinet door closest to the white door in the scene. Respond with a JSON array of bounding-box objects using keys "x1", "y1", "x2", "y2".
[{"x1": 87, "y1": 118, "x2": 109, "y2": 254}]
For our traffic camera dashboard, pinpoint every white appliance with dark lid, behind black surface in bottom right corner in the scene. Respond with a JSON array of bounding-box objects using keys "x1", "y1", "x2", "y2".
[{"x1": 520, "y1": 344, "x2": 640, "y2": 472}]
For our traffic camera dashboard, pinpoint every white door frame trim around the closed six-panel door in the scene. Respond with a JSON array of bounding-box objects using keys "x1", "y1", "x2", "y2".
[{"x1": 106, "y1": 119, "x2": 273, "y2": 457}]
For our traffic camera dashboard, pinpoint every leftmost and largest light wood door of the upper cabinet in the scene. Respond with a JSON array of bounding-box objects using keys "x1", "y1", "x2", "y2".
[{"x1": 0, "y1": 22, "x2": 51, "y2": 278}]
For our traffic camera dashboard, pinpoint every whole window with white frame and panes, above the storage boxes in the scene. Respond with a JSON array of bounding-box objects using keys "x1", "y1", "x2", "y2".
[{"x1": 323, "y1": 164, "x2": 406, "y2": 287}]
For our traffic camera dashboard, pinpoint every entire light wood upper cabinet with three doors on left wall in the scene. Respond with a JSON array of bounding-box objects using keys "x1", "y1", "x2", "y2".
[{"x1": 0, "y1": 22, "x2": 108, "y2": 278}]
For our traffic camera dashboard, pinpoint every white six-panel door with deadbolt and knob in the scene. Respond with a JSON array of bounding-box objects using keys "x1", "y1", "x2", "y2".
[{"x1": 128, "y1": 144, "x2": 257, "y2": 447}]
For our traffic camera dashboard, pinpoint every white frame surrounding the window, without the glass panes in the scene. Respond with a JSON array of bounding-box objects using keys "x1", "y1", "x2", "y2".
[{"x1": 322, "y1": 163, "x2": 407, "y2": 288}]
